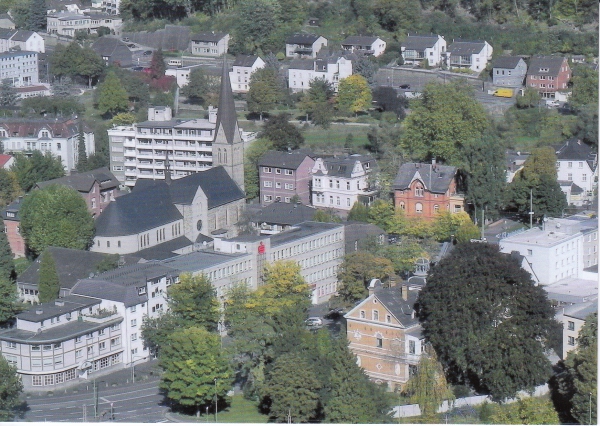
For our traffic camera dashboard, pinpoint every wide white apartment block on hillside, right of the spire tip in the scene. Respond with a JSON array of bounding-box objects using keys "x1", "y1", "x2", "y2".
[{"x1": 288, "y1": 56, "x2": 352, "y2": 92}]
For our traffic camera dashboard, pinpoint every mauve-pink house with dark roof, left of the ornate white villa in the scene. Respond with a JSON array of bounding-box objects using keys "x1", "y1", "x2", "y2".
[{"x1": 258, "y1": 150, "x2": 315, "y2": 206}]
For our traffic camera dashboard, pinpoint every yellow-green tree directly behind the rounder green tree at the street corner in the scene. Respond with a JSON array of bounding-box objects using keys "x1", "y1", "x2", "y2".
[{"x1": 169, "y1": 274, "x2": 220, "y2": 332}]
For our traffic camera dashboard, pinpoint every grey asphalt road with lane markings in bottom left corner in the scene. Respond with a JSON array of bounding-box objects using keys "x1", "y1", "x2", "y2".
[{"x1": 17, "y1": 378, "x2": 169, "y2": 423}]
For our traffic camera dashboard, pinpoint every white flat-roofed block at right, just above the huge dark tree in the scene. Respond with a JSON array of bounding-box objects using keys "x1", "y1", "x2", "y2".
[{"x1": 500, "y1": 223, "x2": 584, "y2": 284}]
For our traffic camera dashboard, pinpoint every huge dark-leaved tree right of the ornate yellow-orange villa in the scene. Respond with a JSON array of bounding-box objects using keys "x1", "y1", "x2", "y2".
[{"x1": 418, "y1": 243, "x2": 559, "y2": 401}]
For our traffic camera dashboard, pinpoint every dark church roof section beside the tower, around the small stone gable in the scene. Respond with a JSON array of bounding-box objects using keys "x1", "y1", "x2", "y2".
[{"x1": 168, "y1": 166, "x2": 245, "y2": 209}]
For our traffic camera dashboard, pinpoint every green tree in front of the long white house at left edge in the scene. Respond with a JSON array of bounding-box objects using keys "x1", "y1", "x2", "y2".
[{"x1": 10, "y1": 151, "x2": 65, "y2": 192}]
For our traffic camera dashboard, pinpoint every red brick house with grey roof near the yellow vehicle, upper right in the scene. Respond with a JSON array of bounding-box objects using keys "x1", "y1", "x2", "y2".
[{"x1": 527, "y1": 56, "x2": 571, "y2": 99}]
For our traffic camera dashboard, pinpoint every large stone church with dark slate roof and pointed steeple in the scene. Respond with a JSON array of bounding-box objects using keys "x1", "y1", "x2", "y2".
[{"x1": 90, "y1": 62, "x2": 245, "y2": 259}]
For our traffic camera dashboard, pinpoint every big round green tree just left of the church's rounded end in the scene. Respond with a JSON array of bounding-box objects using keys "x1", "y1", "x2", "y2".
[{"x1": 20, "y1": 185, "x2": 94, "y2": 256}]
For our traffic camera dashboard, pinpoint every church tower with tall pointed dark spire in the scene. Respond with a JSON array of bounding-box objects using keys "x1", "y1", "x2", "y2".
[{"x1": 213, "y1": 57, "x2": 244, "y2": 190}]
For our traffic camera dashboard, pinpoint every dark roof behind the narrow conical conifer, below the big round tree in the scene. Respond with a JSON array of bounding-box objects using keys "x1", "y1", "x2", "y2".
[{"x1": 17, "y1": 247, "x2": 118, "y2": 288}]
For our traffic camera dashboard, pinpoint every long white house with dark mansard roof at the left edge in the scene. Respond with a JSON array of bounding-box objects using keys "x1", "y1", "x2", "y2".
[{"x1": 0, "y1": 117, "x2": 95, "y2": 172}]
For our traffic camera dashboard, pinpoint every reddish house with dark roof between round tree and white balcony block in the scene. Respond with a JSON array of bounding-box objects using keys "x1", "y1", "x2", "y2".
[{"x1": 34, "y1": 167, "x2": 121, "y2": 217}]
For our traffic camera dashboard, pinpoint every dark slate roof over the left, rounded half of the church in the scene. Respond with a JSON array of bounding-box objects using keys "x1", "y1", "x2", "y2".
[{"x1": 96, "y1": 181, "x2": 183, "y2": 237}]
